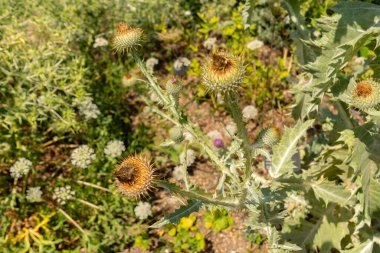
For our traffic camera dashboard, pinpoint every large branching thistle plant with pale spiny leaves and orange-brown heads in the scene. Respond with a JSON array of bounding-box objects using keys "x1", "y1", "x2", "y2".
[{"x1": 111, "y1": 1, "x2": 380, "y2": 252}]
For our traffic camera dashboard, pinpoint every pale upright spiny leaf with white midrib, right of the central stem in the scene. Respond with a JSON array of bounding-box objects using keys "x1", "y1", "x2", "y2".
[{"x1": 269, "y1": 120, "x2": 314, "y2": 178}]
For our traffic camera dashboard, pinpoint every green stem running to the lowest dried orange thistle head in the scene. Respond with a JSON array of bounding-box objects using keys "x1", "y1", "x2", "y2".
[{"x1": 156, "y1": 180, "x2": 242, "y2": 208}]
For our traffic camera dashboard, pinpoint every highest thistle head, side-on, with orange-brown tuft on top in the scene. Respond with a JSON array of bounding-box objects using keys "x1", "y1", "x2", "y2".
[{"x1": 112, "y1": 22, "x2": 144, "y2": 53}]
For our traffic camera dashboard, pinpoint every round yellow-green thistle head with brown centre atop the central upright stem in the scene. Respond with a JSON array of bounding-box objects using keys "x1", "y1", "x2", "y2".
[{"x1": 202, "y1": 51, "x2": 245, "y2": 92}]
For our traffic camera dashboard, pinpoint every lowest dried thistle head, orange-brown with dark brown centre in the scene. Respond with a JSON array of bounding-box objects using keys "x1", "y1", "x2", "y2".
[{"x1": 115, "y1": 155, "x2": 154, "y2": 197}]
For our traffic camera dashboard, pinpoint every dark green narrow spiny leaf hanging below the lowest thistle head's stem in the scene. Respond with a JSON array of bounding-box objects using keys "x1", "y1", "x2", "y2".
[{"x1": 151, "y1": 200, "x2": 202, "y2": 228}]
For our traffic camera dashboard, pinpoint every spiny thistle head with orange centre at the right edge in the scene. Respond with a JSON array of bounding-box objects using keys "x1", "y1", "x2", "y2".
[{"x1": 350, "y1": 80, "x2": 380, "y2": 109}]
